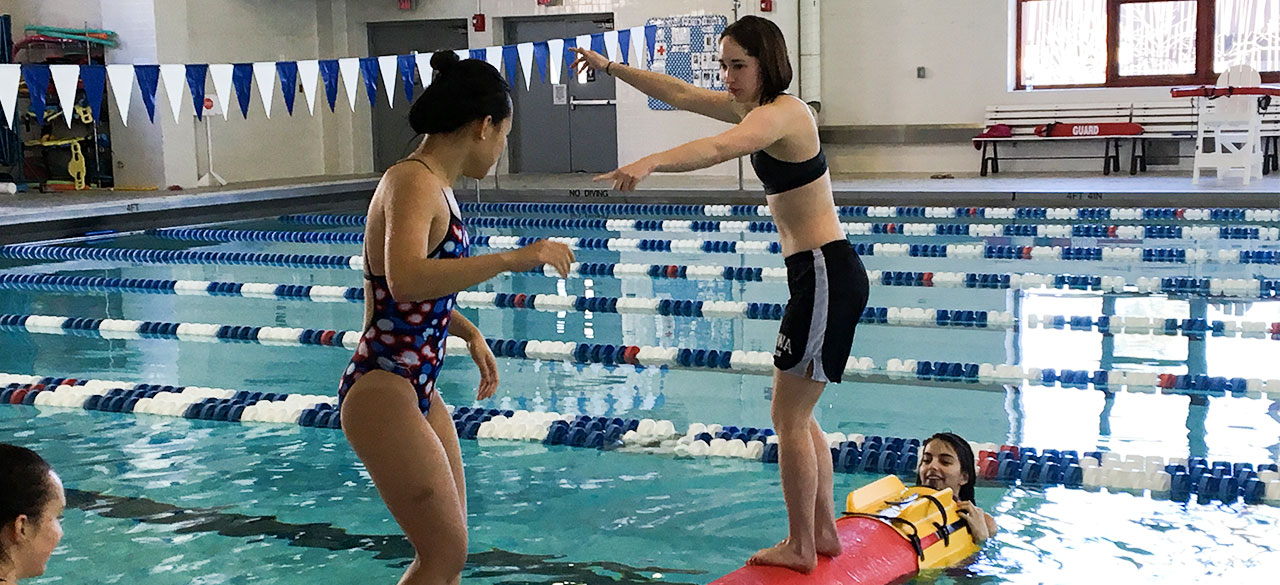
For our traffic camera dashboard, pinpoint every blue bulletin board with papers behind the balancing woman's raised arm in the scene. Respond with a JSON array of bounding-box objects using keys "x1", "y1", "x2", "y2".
[{"x1": 646, "y1": 15, "x2": 728, "y2": 110}]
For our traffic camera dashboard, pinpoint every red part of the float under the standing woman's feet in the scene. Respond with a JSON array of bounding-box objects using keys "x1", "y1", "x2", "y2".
[{"x1": 712, "y1": 517, "x2": 919, "y2": 585}]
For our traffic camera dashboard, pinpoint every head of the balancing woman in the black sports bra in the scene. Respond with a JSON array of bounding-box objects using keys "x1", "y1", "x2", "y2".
[{"x1": 719, "y1": 15, "x2": 791, "y2": 105}]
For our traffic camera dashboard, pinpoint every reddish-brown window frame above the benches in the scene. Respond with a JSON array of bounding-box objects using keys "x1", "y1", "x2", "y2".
[{"x1": 1014, "y1": 0, "x2": 1280, "y2": 91}]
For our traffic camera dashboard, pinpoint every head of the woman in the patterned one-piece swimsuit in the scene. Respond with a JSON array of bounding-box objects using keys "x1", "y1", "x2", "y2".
[{"x1": 408, "y1": 51, "x2": 511, "y2": 179}]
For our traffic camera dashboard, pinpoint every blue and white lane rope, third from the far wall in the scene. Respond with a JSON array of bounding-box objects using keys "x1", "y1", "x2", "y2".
[{"x1": 147, "y1": 228, "x2": 1280, "y2": 265}]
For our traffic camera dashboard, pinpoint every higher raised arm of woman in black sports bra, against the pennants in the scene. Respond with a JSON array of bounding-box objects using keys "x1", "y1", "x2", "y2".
[{"x1": 571, "y1": 49, "x2": 742, "y2": 124}]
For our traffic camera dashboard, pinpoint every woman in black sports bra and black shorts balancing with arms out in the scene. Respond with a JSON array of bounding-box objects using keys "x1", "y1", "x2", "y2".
[{"x1": 573, "y1": 17, "x2": 868, "y2": 572}]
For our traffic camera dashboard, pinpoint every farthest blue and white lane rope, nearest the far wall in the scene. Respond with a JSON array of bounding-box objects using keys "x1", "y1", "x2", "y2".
[{"x1": 285, "y1": 202, "x2": 1280, "y2": 225}]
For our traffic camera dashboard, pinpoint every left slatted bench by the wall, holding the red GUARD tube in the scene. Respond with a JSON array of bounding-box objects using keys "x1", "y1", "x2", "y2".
[{"x1": 974, "y1": 102, "x2": 1133, "y2": 177}]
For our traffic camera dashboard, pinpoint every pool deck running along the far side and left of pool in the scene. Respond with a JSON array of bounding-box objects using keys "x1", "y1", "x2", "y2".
[{"x1": 0, "y1": 173, "x2": 1280, "y2": 243}]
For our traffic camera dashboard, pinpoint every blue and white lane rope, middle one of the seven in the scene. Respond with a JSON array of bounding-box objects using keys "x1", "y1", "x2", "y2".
[{"x1": 0, "y1": 244, "x2": 1280, "y2": 298}]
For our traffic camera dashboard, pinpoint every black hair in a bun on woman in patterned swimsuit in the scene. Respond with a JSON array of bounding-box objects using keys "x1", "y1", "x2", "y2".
[{"x1": 408, "y1": 51, "x2": 511, "y2": 134}]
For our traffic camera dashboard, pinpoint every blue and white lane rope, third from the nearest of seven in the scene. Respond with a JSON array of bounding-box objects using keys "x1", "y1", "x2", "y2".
[{"x1": 0, "y1": 273, "x2": 1280, "y2": 339}]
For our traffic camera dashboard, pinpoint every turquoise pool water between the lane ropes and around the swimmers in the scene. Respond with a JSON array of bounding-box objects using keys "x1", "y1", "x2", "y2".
[{"x1": 0, "y1": 207, "x2": 1280, "y2": 584}]
